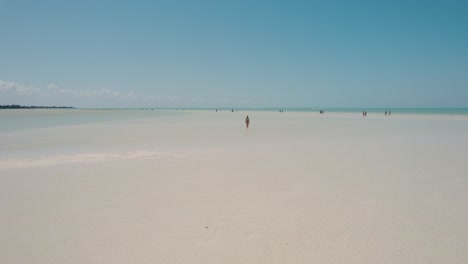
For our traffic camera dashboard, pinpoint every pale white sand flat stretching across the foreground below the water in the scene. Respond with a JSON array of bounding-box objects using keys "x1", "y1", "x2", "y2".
[{"x1": 0, "y1": 111, "x2": 468, "y2": 264}]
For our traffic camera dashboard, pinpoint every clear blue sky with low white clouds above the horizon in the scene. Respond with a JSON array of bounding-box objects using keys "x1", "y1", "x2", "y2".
[{"x1": 0, "y1": 0, "x2": 468, "y2": 108}]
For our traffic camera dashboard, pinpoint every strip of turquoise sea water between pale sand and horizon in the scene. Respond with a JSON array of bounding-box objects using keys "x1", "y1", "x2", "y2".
[{"x1": 0, "y1": 108, "x2": 468, "y2": 132}]
